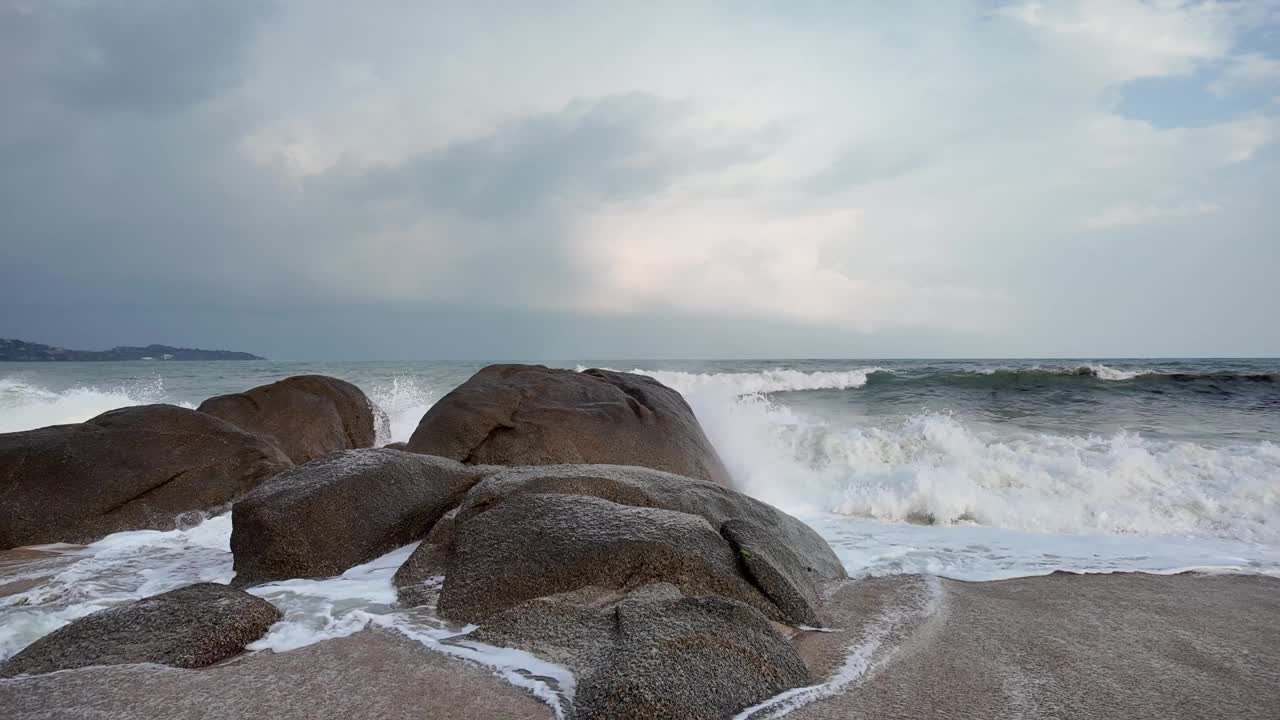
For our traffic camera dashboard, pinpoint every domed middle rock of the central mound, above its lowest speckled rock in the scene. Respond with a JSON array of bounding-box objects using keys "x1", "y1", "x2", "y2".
[{"x1": 439, "y1": 493, "x2": 781, "y2": 623}]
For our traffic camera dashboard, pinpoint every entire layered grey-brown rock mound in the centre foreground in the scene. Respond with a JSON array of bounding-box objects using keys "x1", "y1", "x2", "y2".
[{"x1": 409, "y1": 465, "x2": 846, "y2": 720}]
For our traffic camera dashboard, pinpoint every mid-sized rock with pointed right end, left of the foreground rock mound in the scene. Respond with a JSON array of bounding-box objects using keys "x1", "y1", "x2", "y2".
[{"x1": 232, "y1": 448, "x2": 494, "y2": 585}]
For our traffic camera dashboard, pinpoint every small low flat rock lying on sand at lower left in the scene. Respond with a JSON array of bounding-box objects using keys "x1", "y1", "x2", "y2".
[{"x1": 0, "y1": 583, "x2": 280, "y2": 678}]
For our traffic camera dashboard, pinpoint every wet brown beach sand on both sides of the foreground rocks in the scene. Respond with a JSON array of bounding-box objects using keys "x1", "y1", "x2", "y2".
[{"x1": 0, "y1": 571, "x2": 1280, "y2": 720}]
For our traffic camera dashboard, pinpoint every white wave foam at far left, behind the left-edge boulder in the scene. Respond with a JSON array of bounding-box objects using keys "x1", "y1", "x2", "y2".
[{"x1": 0, "y1": 377, "x2": 193, "y2": 433}]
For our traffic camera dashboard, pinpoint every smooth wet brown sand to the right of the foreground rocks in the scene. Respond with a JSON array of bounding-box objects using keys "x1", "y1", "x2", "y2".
[{"x1": 788, "y1": 573, "x2": 1280, "y2": 720}]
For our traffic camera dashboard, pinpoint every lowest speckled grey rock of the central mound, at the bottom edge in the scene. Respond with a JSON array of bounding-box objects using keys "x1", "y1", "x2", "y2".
[{"x1": 470, "y1": 584, "x2": 812, "y2": 720}]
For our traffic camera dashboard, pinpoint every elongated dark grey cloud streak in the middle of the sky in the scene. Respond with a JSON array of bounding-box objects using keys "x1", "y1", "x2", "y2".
[{"x1": 339, "y1": 94, "x2": 768, "y2": 218}]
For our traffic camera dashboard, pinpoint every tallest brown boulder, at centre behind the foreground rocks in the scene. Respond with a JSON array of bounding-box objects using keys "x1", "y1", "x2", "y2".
[{"x1": 407, "y1": 365, "x2": 730, "y2": 486}]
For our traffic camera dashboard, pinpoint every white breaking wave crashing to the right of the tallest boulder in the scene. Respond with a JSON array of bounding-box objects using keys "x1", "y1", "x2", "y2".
[{"x1": 686, "y1": 379, "x2": 1280, "y2": 542}]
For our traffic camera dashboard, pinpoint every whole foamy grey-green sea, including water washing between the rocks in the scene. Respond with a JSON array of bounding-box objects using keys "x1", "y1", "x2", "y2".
[{"x1": 0, "y1": 359, "x2": 1280, "y2": 707}]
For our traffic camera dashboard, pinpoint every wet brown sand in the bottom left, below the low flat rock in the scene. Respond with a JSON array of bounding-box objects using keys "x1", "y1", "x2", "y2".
[{"x1": 0, "y1": 629, "x2": 556, "y2": 720}]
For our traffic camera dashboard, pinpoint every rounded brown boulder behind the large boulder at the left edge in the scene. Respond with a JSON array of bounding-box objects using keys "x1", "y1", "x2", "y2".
[{"x1": 197, "y1": 375, "x2": 389, "y2": 465}]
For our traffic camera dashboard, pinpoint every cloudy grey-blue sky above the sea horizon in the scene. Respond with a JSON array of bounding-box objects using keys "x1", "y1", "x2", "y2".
[{"x1": 0, "y1": 0, "x2": 1280, "y2": 360}]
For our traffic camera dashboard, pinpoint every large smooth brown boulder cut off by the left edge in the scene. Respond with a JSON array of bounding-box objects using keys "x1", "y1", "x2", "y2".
[{"x1": 0, "y1": 405, "x2": 292, "y2": 548}]
